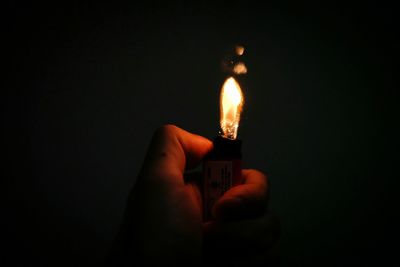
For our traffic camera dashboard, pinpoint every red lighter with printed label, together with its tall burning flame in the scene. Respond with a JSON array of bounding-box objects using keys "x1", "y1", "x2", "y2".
[{"x1": 203, "y1": 77, "x2": 244, "y2": 221}]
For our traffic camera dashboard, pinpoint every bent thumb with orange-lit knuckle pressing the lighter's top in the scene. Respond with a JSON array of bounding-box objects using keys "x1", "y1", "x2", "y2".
[{"x1": 139, "y1": 125, "x2": 212, "y2": 184}]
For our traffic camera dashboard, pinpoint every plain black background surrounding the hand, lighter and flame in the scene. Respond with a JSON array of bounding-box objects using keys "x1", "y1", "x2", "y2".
[{"x1": 0, "y1": 1, "x2": 398, "y2": 266}]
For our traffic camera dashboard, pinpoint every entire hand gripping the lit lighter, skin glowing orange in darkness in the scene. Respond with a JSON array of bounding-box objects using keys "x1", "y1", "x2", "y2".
[{"x1": 109, "y1": 125, "x2": 280, "y2": 266}]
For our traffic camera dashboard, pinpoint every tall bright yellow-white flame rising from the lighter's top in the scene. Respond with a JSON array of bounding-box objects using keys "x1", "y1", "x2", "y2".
[{"x1": 220, "y1": 77, "x2": 243, "y2": 139}]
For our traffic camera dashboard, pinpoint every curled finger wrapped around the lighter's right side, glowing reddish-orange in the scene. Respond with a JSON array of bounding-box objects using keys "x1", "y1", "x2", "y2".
[{"x1": 212, "y1": 170, "x2": 269, "y2": 220}]
